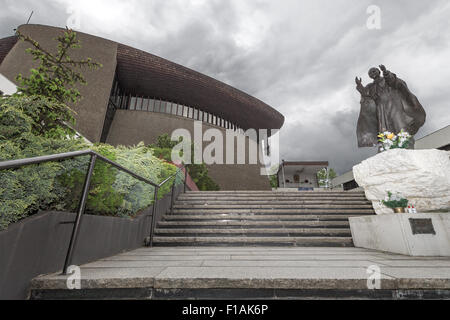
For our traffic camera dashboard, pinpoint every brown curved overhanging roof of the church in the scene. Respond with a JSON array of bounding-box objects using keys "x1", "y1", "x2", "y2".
[{"x1": 0, "y1": 26, "x2": 284, "y2": 129}]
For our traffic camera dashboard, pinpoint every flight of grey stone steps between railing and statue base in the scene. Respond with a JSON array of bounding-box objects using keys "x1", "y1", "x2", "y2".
[{"x1": 154, "y1": 191, "x2": 375, "y2": 247}]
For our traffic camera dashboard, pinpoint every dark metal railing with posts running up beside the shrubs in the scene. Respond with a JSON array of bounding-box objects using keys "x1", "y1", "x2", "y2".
[{"x1": 0, "y1": 150, "x2": 188, "y2": 275}]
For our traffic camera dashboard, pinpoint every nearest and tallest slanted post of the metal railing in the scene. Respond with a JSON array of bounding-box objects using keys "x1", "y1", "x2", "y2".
[{"x1": 63, "y1": 154, "x2": 97, "y2": 275}]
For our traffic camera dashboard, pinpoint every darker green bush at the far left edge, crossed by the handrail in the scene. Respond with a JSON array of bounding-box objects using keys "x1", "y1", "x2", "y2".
[{"x1": 0, "y1": 97, "x2": 87, "y2": 229}]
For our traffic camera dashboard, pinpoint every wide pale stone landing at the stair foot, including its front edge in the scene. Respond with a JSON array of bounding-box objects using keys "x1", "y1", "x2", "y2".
[{"x1": 31, "y1": 247, "x2": 450, "y2": 300}]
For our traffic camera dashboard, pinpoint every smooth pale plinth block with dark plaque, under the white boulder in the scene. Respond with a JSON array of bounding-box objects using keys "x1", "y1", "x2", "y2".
[{"x1": 349, "y1": 213, "x2": 450, "y2": 257}]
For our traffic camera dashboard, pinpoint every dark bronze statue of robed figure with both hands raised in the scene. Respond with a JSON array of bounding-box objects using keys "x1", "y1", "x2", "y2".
[{"x1": 355, "y1": 65, "x2": 426, "y2": 148}]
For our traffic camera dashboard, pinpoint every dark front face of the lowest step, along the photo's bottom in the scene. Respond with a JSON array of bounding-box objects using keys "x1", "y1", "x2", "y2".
[{"x1": 31, "y1": 288, "x2": 450, "y2": 300}]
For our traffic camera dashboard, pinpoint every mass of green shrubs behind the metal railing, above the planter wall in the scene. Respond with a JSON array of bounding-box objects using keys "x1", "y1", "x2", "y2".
[{"x1": 0, "y1": 96, "x2": 179, "y2": 230}]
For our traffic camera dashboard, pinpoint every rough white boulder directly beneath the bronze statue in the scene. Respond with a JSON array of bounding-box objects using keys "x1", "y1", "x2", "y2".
[{"x1": 353, "y1": 149, "x2": 450, "y2": 215}]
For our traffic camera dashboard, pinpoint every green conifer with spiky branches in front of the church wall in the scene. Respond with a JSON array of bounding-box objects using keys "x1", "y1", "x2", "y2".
[{"x1": 16, "y1": 29, "x2": 102, "y2": 103}]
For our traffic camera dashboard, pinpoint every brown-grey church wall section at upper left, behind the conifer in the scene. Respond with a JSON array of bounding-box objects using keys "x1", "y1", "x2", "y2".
[{"x1": 0, "y1": 25, "x2": 117, "y2": 142}]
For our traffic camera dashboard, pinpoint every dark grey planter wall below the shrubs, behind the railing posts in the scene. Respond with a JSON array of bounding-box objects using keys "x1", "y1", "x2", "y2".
[{"x1": 0, "y1": 185, "x2": 183, "y2": 300}]
